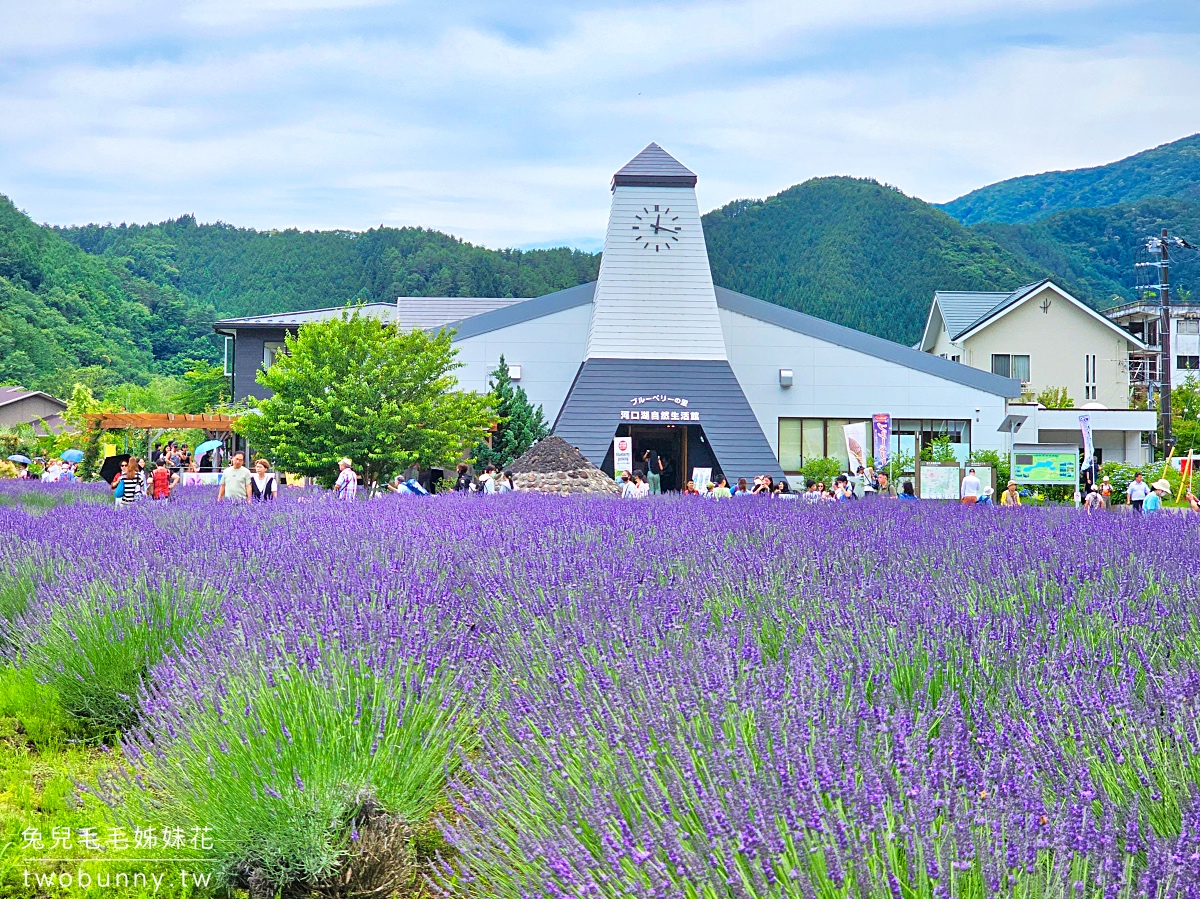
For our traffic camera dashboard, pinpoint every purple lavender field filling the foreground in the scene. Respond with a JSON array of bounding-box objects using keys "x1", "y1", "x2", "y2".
[{"x1": 7, "y1": 487, "x2": 1200, "y2": 899}]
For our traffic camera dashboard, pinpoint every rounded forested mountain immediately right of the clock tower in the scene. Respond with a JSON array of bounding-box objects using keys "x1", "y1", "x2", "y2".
[{"x1": 703, "y1": 178, "x2": 1049, "y2": 343}]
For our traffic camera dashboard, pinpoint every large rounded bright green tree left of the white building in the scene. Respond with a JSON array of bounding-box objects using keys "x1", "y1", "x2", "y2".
[{"x1": 238, "y1": 310, "x2": 493, "y2": 486}]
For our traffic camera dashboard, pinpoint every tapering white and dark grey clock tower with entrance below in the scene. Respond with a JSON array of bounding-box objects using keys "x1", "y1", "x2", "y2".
[{"x1": 554, "y1": 144, "x2": 784, "y2": 480}]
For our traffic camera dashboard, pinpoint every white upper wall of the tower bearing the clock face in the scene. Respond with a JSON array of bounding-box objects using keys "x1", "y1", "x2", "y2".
[{"x1": 587, "y1": 186, "x2": 725, "y2": 359}]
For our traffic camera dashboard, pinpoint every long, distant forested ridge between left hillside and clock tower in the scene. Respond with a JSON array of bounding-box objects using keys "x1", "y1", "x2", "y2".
[{"x1": 60, "y1": 216, "x2": 600, "y2": 318}]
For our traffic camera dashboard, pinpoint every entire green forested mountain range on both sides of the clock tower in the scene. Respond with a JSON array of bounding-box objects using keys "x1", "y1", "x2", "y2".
[{"x1": 7, "y1": 134, "x2": 1200, "y2": 395}]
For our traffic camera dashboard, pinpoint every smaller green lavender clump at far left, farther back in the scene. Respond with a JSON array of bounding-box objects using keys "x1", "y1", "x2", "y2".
[{"x1": 13, "y1": 580, "x2": 215, "y2": 739}]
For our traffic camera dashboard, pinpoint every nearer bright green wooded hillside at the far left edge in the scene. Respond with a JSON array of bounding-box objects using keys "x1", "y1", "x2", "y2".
[{"x1": 0, "y1": 196, "x2": 217, "y2": 396}]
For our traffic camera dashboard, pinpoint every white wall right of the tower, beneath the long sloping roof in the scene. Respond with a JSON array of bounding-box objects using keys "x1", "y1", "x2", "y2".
[{"x1": 720, "y1": 310, "x2": 1008, "y2": 456}]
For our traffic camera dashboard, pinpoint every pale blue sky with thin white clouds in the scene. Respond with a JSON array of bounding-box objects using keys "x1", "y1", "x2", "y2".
[{"x1": 0, "y1": 0, "x2": 1200, "y2": 250}]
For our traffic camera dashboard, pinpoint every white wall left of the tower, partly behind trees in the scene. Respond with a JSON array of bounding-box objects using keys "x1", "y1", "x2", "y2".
[{"x1": 454, "y1": 305, "x2": 592, "y2": 425}]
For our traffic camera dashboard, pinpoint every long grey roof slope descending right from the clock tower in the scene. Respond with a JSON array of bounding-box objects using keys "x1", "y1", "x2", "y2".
[{"x1": 716, "y1": 287, "x2": 1021, "y2": 396}]
